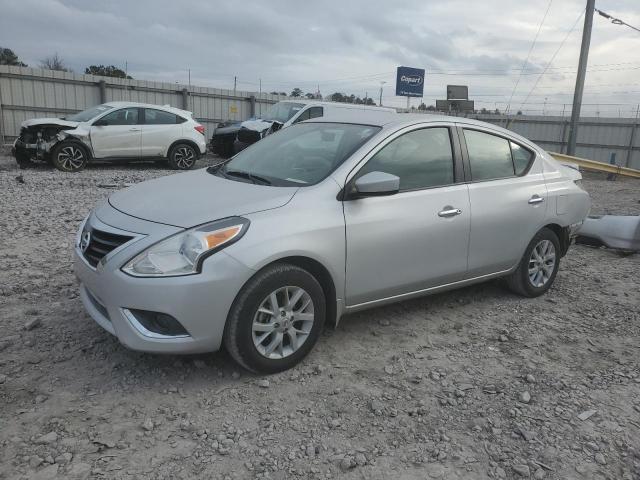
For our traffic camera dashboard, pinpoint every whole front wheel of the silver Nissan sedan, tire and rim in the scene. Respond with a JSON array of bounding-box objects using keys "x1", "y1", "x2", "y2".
[{"x1": 224, "y1": 264, "x2": 326, "y2": 373}]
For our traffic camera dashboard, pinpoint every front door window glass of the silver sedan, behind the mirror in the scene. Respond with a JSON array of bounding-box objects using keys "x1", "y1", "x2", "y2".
[{"x1": 358, "y1": 128, "x2": 454, "y2": 190}]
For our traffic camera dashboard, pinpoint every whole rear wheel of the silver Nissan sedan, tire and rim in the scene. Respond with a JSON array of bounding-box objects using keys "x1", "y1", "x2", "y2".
[{"x1": 506, "y1": 228, "x2": 560, "y2": 297}]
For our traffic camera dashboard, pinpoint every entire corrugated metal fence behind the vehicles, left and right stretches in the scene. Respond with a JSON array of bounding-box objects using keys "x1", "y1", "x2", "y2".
[{"x1": 0, "y1": 65, "x2": 640, "y2": 169}]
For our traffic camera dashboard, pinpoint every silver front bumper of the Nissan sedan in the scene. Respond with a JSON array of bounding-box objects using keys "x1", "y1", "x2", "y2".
[{"x1": 74, "y1": 204, "x2": 255, "y2": 353}]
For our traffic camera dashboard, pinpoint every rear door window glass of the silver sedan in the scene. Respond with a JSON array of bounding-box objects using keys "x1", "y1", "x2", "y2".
[{"x1": 464, "y1": 130, "x2": 515, "y2": 181}]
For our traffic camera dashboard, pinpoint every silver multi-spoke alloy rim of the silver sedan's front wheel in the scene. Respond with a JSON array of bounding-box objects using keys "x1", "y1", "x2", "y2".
[{"x1": 251, "y1": 286, "x2": 315, "y2": 359}]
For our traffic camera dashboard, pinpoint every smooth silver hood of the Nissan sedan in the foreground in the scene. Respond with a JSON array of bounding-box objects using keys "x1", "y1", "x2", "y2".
[{"x1": 109, "y1": 169, "x2": 298, "y2": 228}]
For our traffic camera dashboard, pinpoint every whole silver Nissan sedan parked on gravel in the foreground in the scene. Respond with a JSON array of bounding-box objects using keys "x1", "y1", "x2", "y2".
[{"x1": 75, "y1": 115, "x2": 590, "y2": 373}]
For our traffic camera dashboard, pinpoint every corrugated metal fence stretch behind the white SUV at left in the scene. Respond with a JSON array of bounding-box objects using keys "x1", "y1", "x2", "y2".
[{"x1": 0, "y1": 65, "x2": 286, "y2": 143}]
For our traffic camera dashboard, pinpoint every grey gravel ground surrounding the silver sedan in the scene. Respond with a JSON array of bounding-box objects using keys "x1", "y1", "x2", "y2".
[{"x1": 0, "y1": 157, "x2": 640, "y2": 480}]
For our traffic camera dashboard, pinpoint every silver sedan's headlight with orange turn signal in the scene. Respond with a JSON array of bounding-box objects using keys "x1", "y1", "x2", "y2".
[{"x1": 122, "y1": 217, "x2": 249, "y2": 277}]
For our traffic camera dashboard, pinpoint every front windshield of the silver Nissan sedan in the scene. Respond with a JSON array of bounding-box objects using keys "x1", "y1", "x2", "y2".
[{"x1": 209, "y1": 123, "x2": 380, "y2": 187}]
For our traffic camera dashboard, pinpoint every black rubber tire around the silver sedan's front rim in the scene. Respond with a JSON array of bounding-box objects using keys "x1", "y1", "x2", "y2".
[{"x1": 224, "y1": 263, "x2": 326, "y2": 374}]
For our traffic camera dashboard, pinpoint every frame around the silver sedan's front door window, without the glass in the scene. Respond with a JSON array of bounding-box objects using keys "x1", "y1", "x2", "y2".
[{"x1": 338, "y1": 122, "x2": 466, "y2": 200}]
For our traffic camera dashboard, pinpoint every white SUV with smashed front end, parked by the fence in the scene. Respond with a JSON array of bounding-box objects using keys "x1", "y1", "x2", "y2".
[{"x1": 13, "y1": 102, "x2": 206, "y2": 172}]
